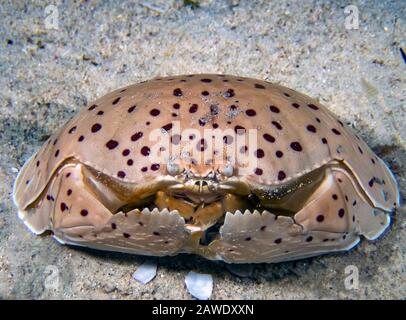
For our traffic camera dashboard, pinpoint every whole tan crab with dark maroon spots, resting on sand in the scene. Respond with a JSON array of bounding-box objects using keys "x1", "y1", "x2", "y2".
[{"x1": 13, "y1": 74, "x2": 399, "y2": 263}]
